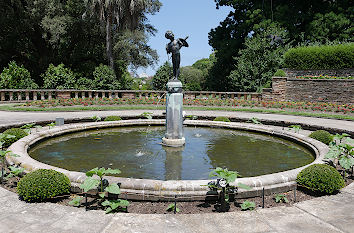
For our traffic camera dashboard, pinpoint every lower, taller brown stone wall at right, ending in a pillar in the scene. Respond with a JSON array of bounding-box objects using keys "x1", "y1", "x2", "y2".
[{"x1": 262, "y1": 77, "x2": 354, "y2": 103}]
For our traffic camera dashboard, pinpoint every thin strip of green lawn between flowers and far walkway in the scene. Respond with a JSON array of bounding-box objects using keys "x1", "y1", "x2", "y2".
[{"x1": 0, "y1": 104, "x2": 354, "y2": 121}]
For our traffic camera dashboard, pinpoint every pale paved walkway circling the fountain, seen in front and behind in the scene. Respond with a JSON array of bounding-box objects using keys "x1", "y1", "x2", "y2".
[{"x1": 0, "y1": 110, "x2": 354, "y2": 233}]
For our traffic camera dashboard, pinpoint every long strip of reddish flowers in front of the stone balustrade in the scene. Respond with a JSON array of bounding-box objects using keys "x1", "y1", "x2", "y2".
[{"x1": 24, "y1": 97, "x2": 354, "y2": 114}]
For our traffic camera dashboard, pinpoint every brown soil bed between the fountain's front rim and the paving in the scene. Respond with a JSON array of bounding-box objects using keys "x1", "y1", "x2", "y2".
[{"x1": 0, "y1": 164, "x2": 354, "y2": 214}]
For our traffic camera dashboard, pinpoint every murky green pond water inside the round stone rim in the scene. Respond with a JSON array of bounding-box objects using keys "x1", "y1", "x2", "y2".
[{"x1": 29, "y1": 126, "x2": 314, "y2": 180}]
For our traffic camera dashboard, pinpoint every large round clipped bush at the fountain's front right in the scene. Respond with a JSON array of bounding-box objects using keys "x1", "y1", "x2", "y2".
[{"x1": 296, "y1": 164, "x2": 345, "y2": 194}]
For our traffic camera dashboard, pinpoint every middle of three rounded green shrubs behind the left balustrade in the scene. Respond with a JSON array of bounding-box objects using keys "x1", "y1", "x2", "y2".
[{"x1": 41, "y1": 64, "x2": 77, "y2": 89}]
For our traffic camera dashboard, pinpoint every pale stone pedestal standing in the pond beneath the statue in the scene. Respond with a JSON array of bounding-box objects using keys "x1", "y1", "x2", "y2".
[{"x1": 162, "y1": 80, "x2": 185, "y2": 147}]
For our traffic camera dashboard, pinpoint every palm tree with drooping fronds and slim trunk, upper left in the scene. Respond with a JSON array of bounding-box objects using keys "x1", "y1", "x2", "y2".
[{"x1": 85, "y1": 0, "x2": 161, "y2": 70}]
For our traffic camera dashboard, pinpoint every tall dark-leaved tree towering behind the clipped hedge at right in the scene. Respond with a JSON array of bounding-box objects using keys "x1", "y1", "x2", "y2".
[{"x1": 209, "y1": 0, "x2": 354, "y2": 91}]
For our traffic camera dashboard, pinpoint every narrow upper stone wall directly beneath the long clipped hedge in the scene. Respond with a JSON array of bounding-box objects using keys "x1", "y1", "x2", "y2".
[{"x1": 283, "y1": 69, "x2": 354, "y2": 78}]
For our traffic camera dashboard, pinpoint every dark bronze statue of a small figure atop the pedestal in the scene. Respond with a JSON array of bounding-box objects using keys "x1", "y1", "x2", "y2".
[{"x1": 165, "y1": 31, "x2": 189, "y2": 80}]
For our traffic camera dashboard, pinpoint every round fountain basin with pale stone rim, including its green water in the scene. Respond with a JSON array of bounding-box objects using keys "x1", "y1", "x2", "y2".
[{"x1": 9, "y1": 120, "x2": 328, "y2": 200}]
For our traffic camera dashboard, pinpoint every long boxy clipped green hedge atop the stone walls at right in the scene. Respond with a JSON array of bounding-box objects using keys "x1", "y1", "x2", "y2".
[{"x1": 284, "y1": 43, "x2": 354, "y2": 70}]
